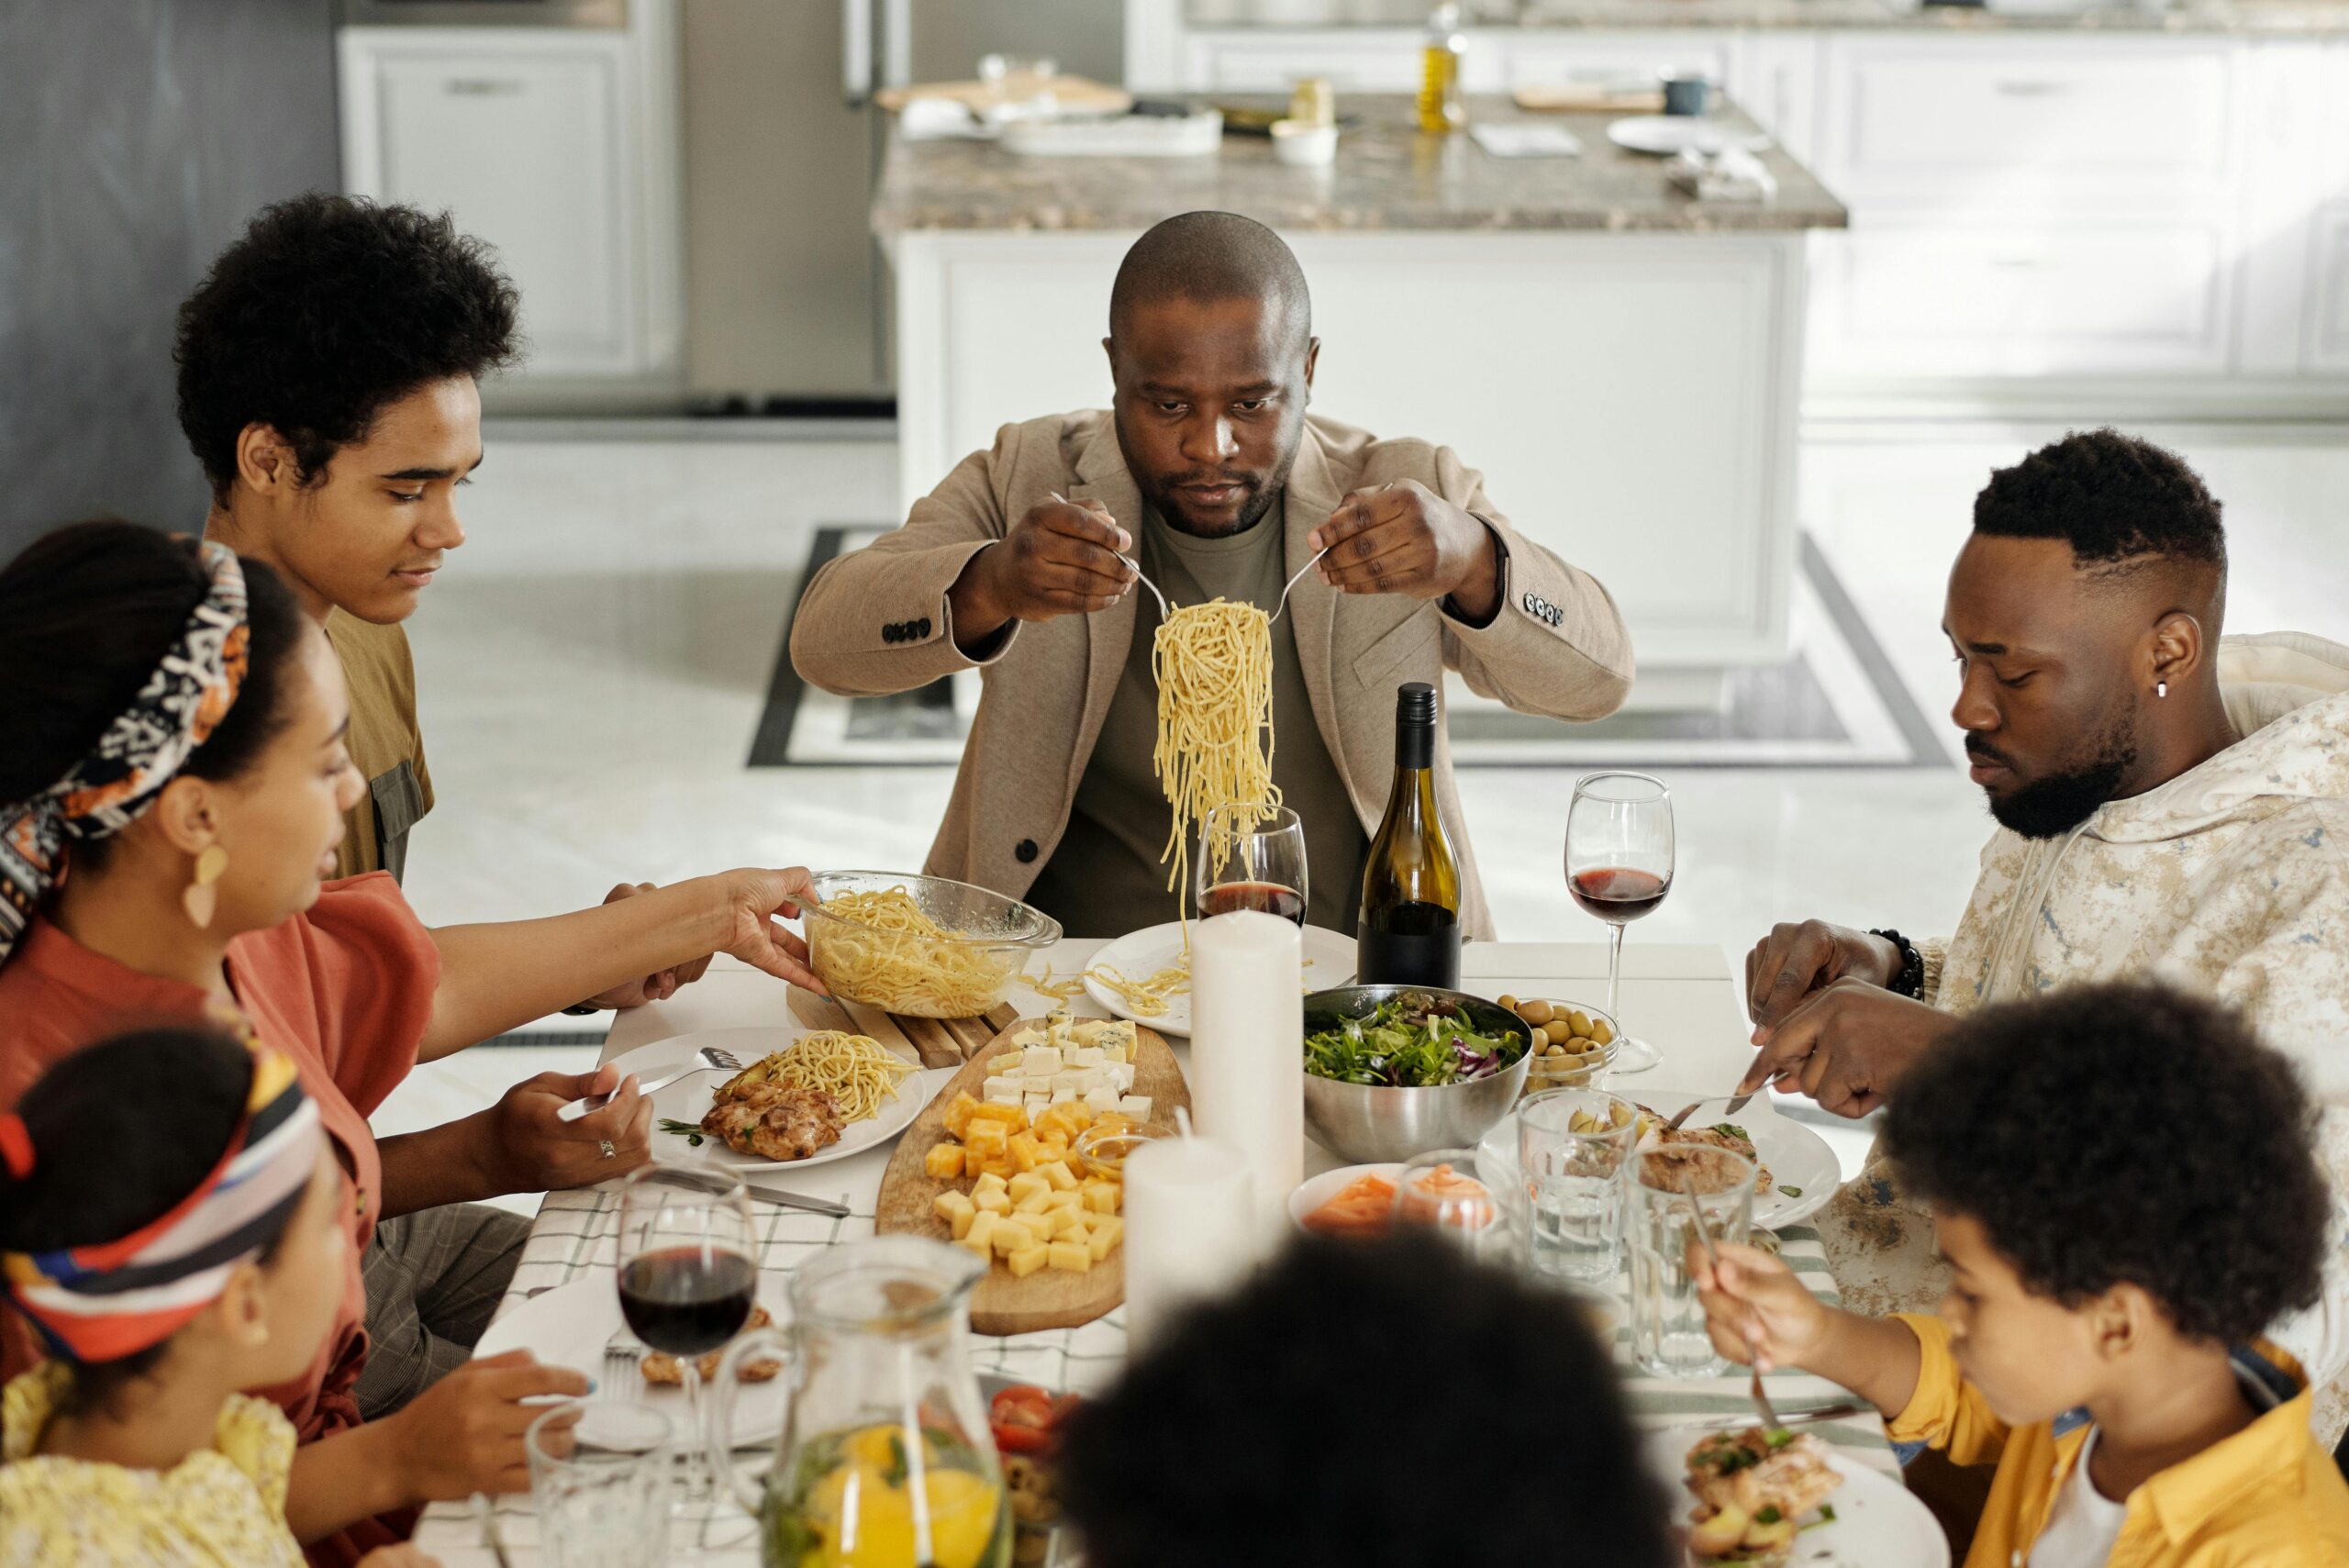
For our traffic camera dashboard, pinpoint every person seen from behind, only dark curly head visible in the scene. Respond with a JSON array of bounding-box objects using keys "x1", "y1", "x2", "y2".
[{"x1": 1060, "y1": 1232, "x2": 1679, "y2": 1568}]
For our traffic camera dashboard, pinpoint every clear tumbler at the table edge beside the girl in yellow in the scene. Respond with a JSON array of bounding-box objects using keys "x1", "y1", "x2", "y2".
[{"x1": 521, "y1": 1399, "x2": 676, "y2": 1568}]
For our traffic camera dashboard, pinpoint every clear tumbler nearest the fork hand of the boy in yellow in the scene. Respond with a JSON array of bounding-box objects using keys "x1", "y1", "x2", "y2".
[{"x1": 1626, "y1": 1143, "x2": 1754, "y2": 1378}]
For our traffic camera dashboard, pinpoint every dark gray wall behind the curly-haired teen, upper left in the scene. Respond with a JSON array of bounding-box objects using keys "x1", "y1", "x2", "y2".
[{"x1": 0, "y1": 0, "x2": 340, "y2": 556}]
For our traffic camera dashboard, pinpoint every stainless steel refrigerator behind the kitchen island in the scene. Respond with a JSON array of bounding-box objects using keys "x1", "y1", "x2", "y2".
[{"x1": 681, "y1": 0, "x2": 1123, "y2": 413}]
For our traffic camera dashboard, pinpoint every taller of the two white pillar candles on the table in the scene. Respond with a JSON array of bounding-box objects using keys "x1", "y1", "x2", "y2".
[{"x1": 1191, "y1": 908, "x2": 1306, "y2": 1256}]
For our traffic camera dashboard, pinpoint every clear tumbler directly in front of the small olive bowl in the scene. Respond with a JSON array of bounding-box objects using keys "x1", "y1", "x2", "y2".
[{"x1": 1518, "y1": 1089, "x2": 1640, "y2": 1284}]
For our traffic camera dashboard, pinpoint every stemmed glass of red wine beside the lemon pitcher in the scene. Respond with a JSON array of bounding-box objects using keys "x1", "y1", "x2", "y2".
[{"x1": 620, "y1": 1164, "x2": 759, "y2": 1502}]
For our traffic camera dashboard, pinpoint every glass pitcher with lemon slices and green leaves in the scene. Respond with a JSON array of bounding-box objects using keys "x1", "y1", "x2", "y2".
[{"x1": 709, "y1": 1237, "x2": 1012, "y2": 1568}]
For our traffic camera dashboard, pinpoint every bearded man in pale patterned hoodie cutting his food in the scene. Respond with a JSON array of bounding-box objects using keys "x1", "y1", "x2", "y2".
[{"x1": 1745, "y1": 429, "x2": 2349, "y2": 1443}]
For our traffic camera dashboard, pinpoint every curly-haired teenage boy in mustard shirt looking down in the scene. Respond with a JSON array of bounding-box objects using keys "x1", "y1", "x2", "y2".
[{"x1": 173, "y1": 195, "x2": 519, "y2": 875}]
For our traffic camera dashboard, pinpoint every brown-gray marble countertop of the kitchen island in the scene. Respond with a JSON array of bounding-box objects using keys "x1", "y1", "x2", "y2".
[{"x1": 872, "y1": 94, "x2": 1846, "y2": 237}]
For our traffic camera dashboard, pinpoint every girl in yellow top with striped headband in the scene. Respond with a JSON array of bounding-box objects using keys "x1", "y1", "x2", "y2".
[{"x1": 0, "y1": 1029, "x2": 429, "y2": 1568}]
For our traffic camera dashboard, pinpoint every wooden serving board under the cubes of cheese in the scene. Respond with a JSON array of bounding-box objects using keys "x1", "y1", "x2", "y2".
[{"x1": 874, "y1": 1018, "x2": 1191, "y2": 1333}]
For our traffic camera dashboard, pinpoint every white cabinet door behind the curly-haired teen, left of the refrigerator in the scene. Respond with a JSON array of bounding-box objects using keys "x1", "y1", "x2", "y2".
[{"x1": 343, "y1": 28, "x2": 643, "y2": 375}]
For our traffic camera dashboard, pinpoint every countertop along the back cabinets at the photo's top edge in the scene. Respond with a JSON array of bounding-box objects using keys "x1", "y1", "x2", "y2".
[{"x1": 1186, "y1": 0, "x2": 2349, "y2": 38}]
